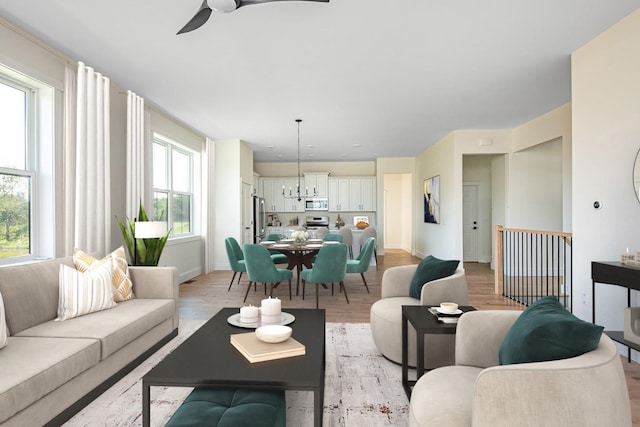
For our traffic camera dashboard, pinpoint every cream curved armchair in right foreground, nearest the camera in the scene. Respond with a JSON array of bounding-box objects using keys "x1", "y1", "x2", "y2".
[{"x1": 409, "y1": 310, "x2": 631, "y2": 427}]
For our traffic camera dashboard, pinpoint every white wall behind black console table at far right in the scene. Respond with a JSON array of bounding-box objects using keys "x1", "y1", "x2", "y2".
[{"x1": 571, "y1": 11, "x2": 640, "y2": 330}]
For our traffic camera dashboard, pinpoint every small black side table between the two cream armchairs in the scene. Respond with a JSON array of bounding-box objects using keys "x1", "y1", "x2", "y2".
[{"x1": 402, "y1": 305, "x2": 475, "y2": 398}]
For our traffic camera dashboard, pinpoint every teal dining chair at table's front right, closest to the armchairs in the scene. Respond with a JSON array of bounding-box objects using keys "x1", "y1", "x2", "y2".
[{"x1": 300, "y1": 244, "x2": 349, "y2": 308}]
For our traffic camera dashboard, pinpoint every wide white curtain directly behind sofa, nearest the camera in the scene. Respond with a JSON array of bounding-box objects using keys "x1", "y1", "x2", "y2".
[{"x1": 64, "y1": 62, "x2": 113, "y2": 255}]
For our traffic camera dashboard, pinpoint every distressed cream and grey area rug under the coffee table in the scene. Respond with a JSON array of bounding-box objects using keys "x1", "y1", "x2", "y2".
[{"x1": 64, "y1": 320, "x2": 409, "y2": 427}]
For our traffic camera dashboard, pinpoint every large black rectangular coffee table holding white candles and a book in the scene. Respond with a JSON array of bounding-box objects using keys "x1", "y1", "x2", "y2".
[{"x1": 142, "y1": 308, "x2": 325, "y2": 426}]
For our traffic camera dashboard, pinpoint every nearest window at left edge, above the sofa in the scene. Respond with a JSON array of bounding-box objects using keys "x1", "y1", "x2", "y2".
[{"x1": 0, "y1": 78, "x2": 37, "y2": 264}]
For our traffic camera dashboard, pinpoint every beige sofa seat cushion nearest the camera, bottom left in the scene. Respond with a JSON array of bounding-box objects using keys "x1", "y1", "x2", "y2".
[{"x1": 0, "y1": 336, "x2": 100, "y2": 424}]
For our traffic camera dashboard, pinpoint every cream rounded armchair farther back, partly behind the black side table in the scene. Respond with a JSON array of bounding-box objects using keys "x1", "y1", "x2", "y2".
[{"x1": 371, "y1": 265, "x2": 468, "y2": 369}]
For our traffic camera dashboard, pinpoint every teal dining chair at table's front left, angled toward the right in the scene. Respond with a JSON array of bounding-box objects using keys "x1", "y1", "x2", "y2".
[{"x1": 243, "y1": 243, "x2": 293, "y2": 301}]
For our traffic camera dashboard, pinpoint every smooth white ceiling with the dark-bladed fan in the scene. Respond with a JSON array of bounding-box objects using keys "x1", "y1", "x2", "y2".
[{"x1": 0, "y1": 0, "x2": 640, "y2": 161}]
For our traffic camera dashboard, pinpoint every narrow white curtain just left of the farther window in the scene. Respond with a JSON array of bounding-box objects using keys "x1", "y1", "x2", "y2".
[{"x1": 126, "y1": 91, "x2": 145, "y2": 219}]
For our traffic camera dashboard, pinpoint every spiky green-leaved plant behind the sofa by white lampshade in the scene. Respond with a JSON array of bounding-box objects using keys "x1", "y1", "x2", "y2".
[{"x1": 118, "y1": 202, "x2": 171, "y2": 266}]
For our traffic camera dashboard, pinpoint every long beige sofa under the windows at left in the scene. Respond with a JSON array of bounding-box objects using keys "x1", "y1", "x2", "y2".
[{"x1": 0, "y1": 257, "x2": 178, "y2": 426}]
